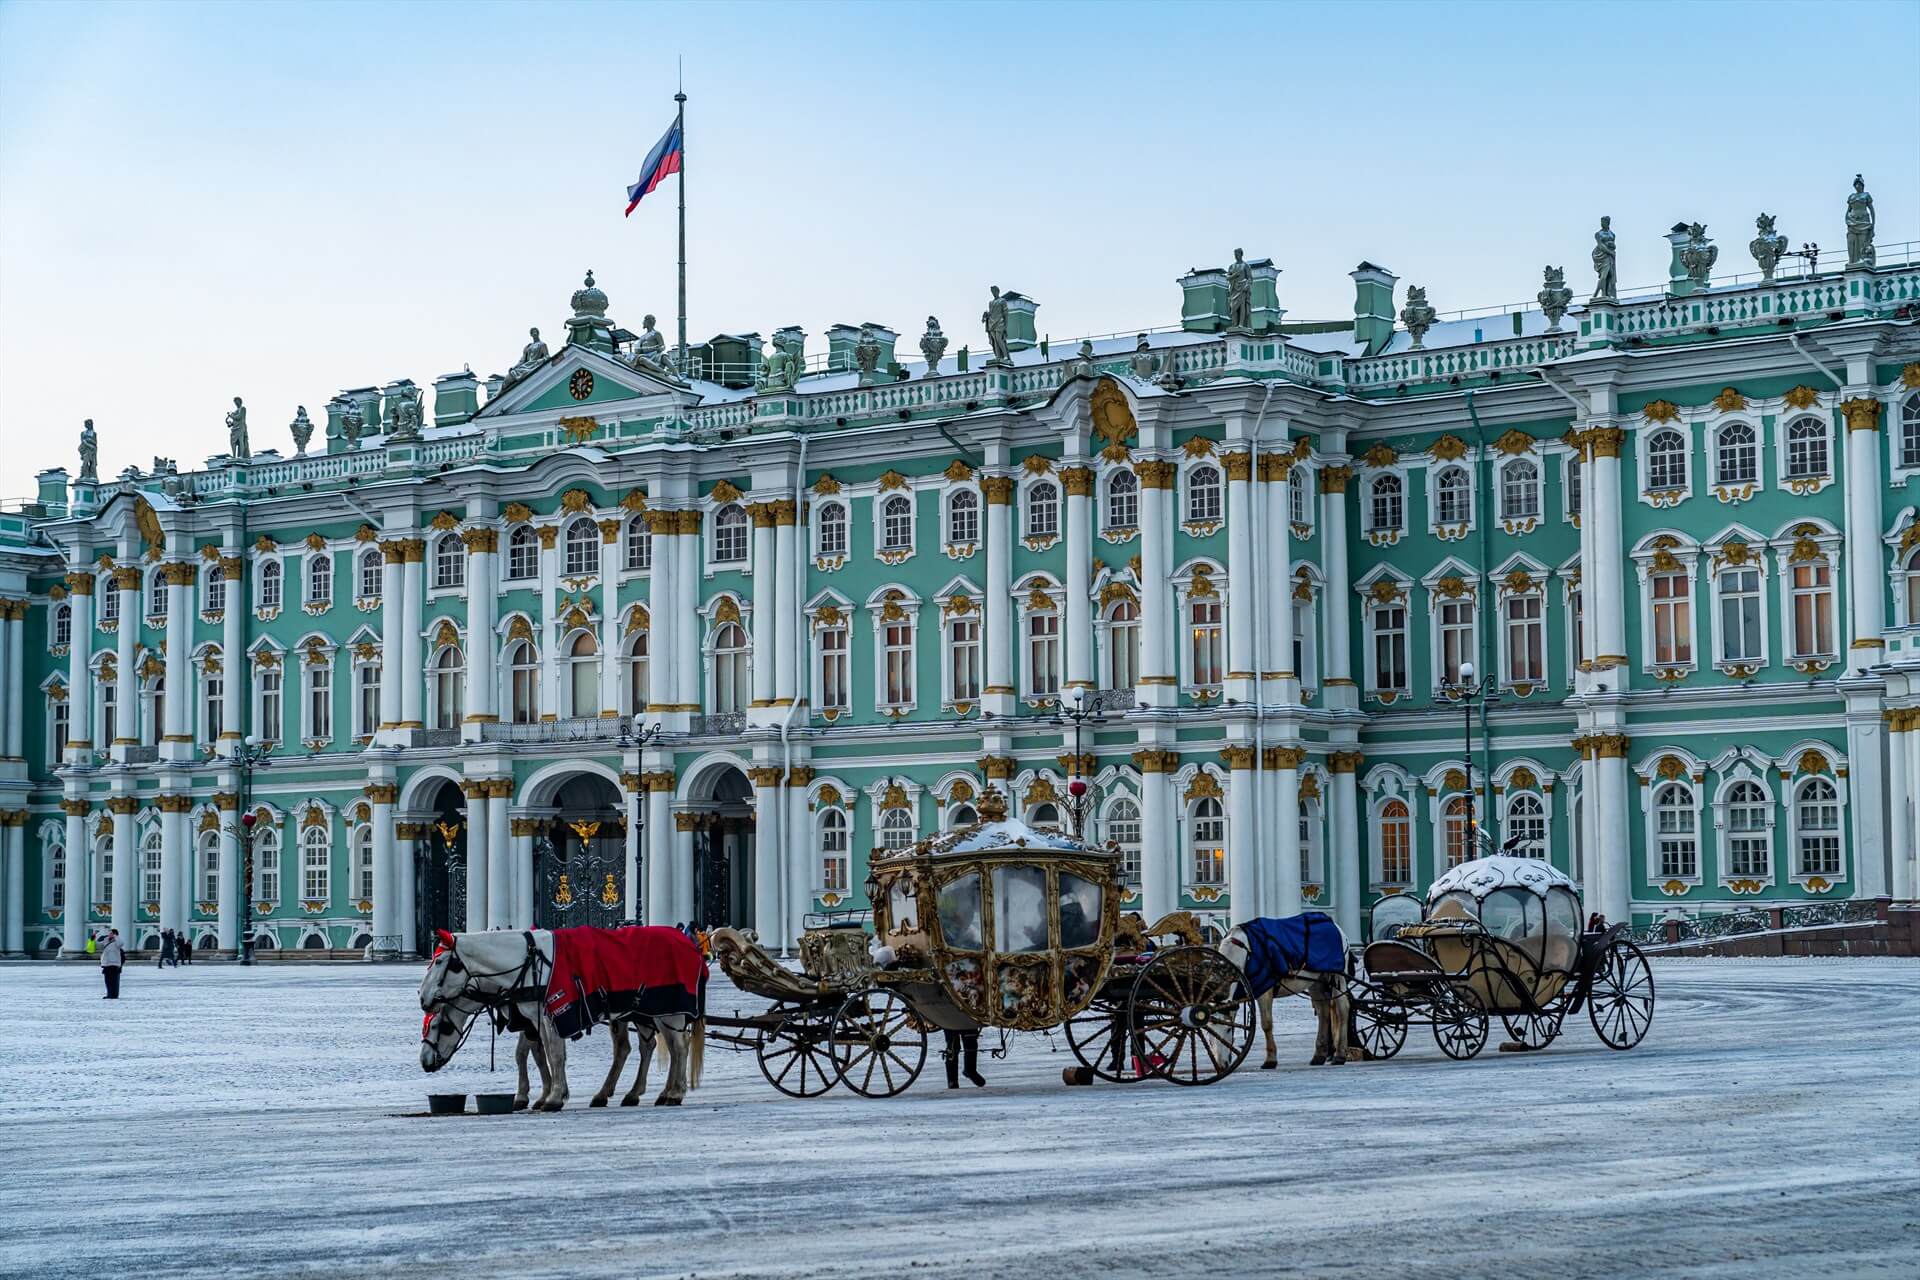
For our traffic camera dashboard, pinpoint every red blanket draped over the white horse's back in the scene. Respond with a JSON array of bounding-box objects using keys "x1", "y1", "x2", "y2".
[{"x1": 547, "y1": 925, "x2": 707, "y2": 1038}]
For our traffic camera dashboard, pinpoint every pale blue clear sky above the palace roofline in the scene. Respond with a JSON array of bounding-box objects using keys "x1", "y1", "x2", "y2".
[{"x1": 0, "y1": 0, "x2": 1920, "y2": 497}]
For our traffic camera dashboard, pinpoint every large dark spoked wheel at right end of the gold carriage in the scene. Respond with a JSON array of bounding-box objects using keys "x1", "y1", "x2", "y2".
[{"x1": 1127, "y1": 946, "x2": 1254, "y2": 1084}]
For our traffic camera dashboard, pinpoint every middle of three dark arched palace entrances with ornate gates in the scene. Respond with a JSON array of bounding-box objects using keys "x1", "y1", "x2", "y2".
[{"x1": 534, "y1": 773, "x2": 626, "y2": 929}]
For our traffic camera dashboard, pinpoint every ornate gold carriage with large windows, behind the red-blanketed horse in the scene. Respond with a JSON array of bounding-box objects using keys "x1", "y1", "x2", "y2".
[{"x1": 707, "y1": 793, "x2": 1254, "y2": 1098}]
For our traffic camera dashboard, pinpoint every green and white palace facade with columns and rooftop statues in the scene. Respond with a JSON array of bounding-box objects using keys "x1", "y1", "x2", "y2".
[{"x1": 0, "y1": 186, "x2": 1920, "y2": 956}]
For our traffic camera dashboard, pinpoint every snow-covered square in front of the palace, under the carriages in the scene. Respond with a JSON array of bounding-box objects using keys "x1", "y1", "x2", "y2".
[{"x1": 0, "y1": 960, "x2": 1920, "y2": 1278}]
